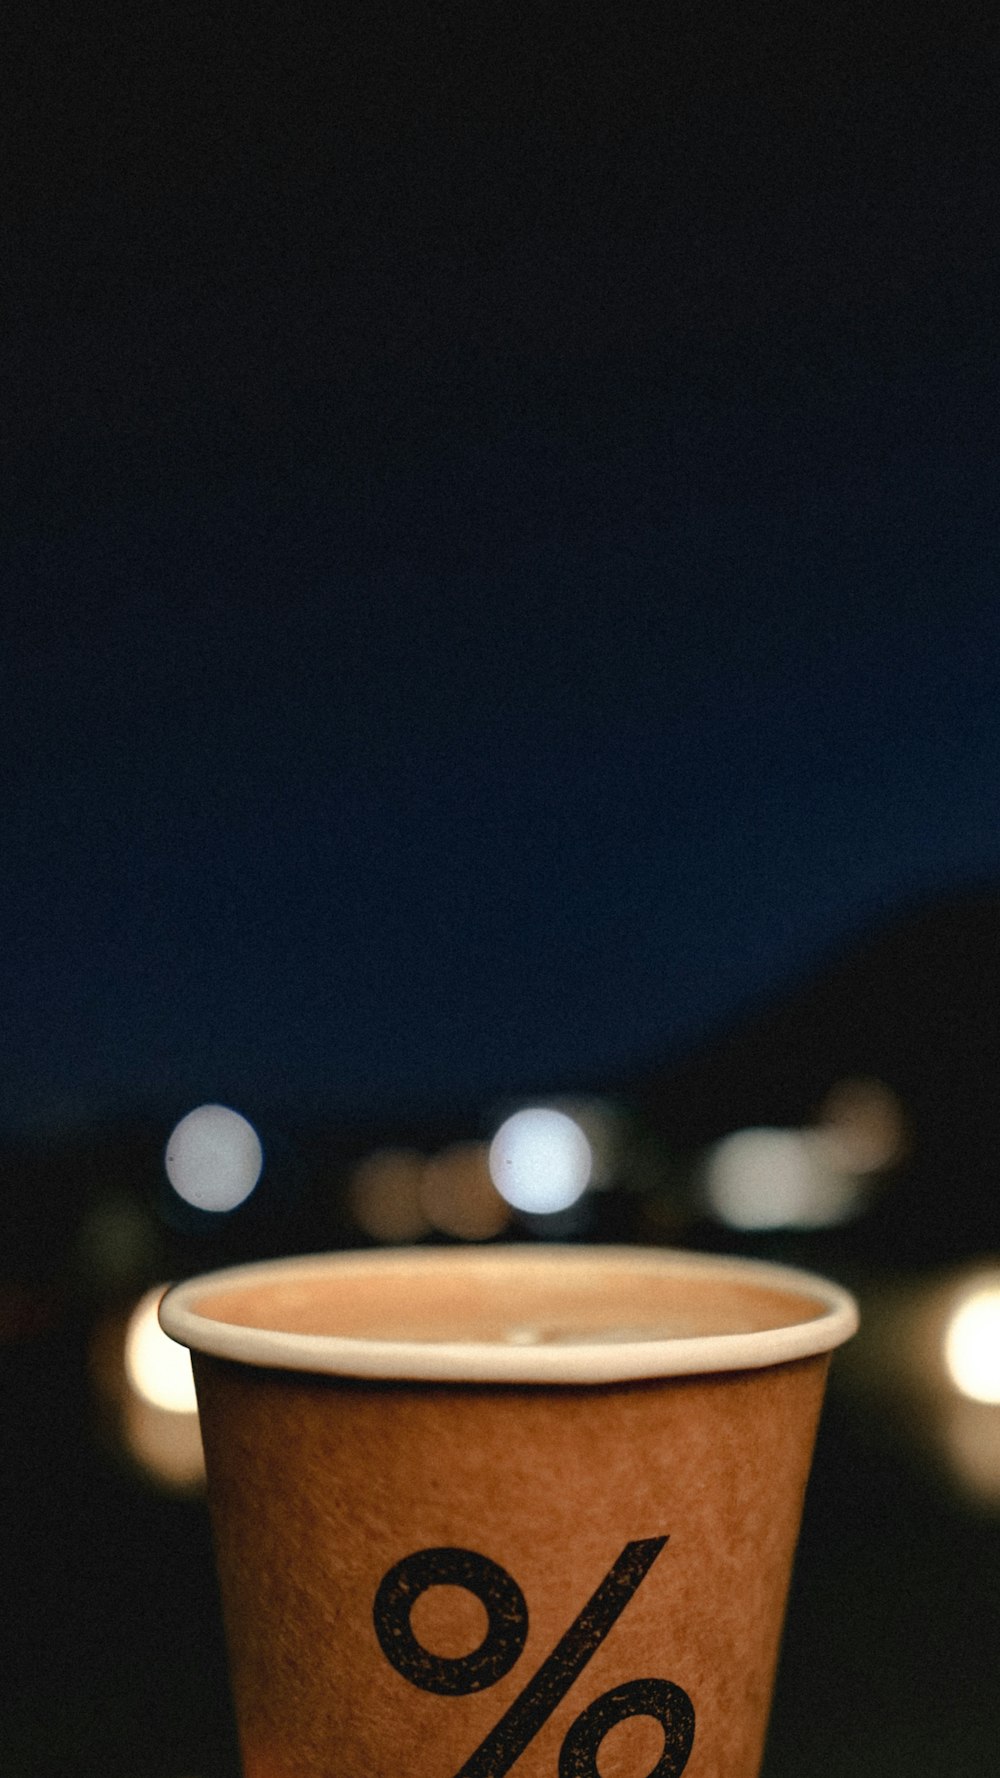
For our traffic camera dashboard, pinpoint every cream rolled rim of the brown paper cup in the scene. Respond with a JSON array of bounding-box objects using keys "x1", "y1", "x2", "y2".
[{"x1": 160, "y1": 1243, "x2": 858, "y2": 1385}]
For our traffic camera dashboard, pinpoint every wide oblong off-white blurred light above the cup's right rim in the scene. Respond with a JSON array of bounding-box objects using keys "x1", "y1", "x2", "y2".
[{"x1": 703, "y1": 1129, "x2": 861, "y2": 1230}]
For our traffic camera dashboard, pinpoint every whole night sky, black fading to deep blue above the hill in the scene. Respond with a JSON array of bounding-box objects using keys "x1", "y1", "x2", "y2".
[{"x1": 0, "y1": 5, "x2": 1000, "y2": 1124}]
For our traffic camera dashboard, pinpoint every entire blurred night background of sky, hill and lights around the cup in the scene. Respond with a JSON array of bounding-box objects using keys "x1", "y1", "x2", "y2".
[{"x1": 0, "y1": 0, "x2": 1000, "y2": 1778}]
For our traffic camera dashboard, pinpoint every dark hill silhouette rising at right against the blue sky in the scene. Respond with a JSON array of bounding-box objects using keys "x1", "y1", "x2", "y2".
[{"x1": 630, "y1": 889, "x2": 1000, "y2": 1262}]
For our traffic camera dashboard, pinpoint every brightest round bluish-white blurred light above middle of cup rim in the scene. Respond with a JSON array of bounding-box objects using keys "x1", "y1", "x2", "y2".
[{"x1": 489, "y1": 1106, "x2": 594, "y2": 1216}]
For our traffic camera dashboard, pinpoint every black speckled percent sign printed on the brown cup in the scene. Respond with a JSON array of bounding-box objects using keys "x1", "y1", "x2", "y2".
[{"x1": 374, "y1": 1538, "x2": 694, "y2": 1778}]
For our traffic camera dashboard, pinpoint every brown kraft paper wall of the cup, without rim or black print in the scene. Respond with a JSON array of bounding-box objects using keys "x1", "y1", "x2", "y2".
[{"x1": 192, "y1": 1351, "x2": 829, "y2": 1778}]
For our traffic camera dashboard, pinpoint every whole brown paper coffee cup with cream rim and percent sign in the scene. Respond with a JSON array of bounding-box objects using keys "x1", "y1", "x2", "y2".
[{"x1": 160, "y1": 1246, "x2": 856, "y2": 1778}]
